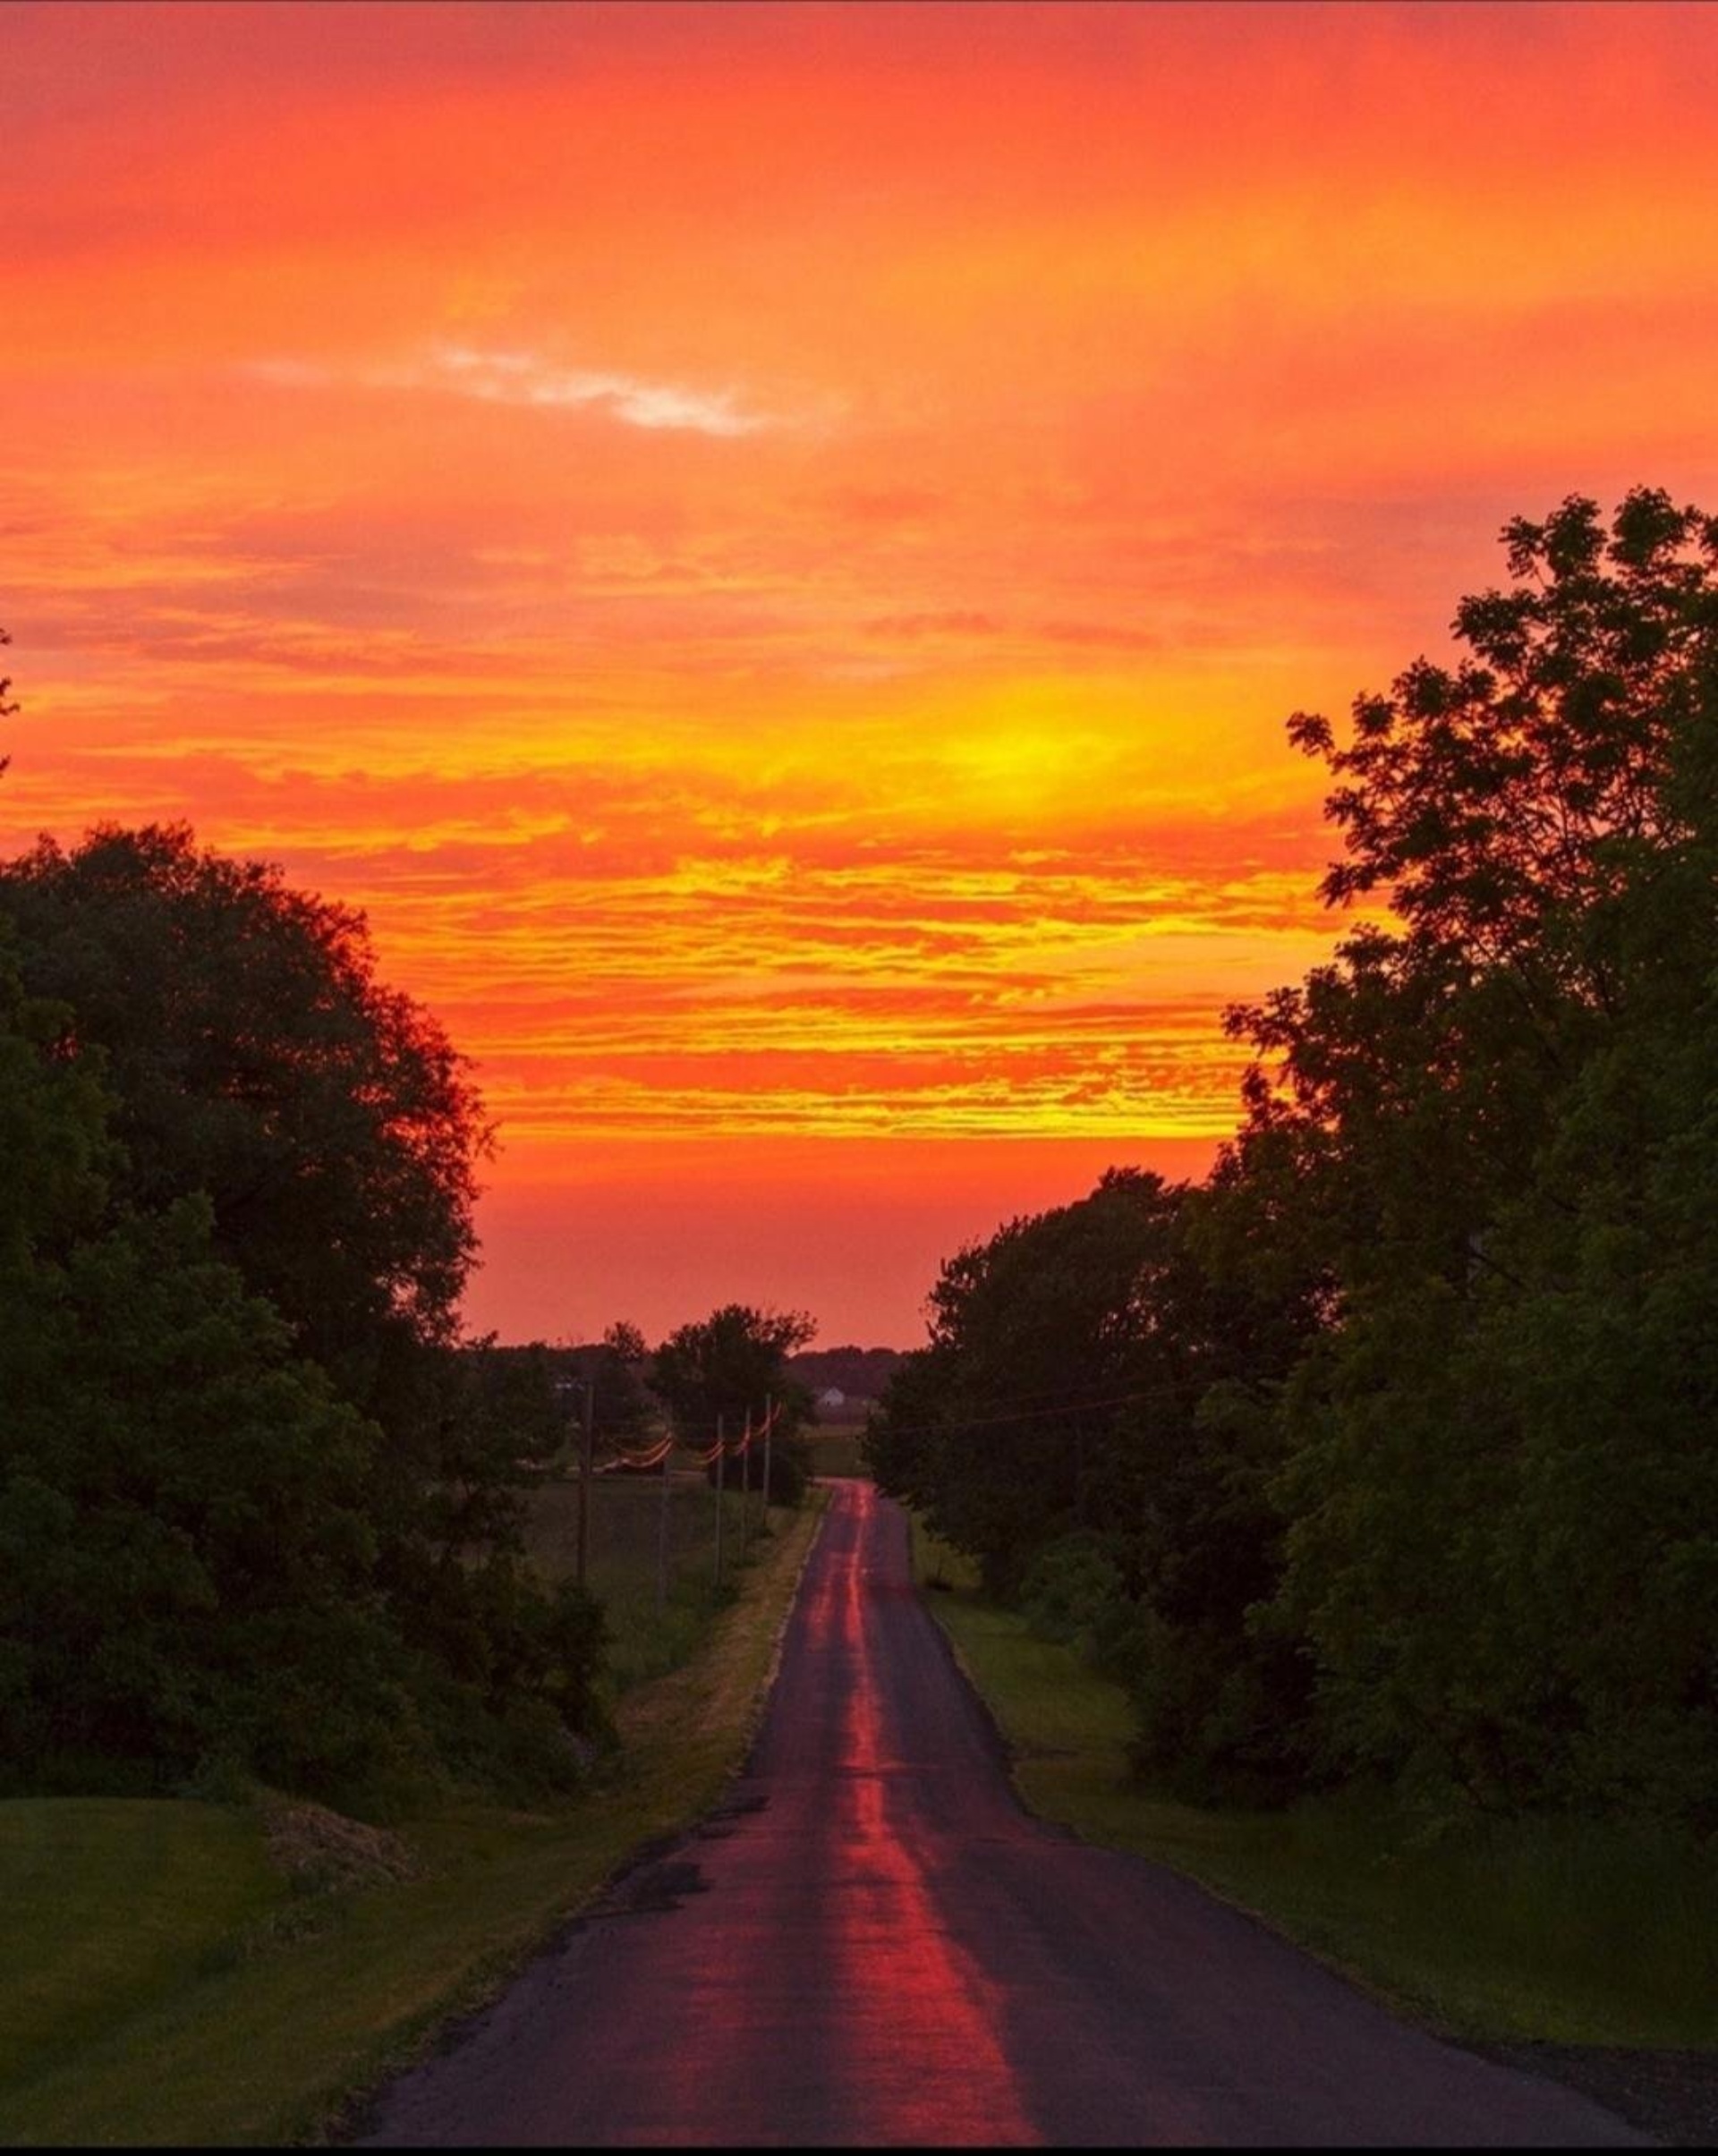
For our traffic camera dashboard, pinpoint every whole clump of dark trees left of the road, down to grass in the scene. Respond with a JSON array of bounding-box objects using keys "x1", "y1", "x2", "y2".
[{"x1": 0, "y1": 830, "x2": 601, "y2": 1800}]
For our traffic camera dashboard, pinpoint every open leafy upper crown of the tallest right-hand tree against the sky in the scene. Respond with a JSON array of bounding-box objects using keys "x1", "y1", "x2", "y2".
[{"x1": 1229, "y1": 489, "x2": 1718, "y2": 1278}]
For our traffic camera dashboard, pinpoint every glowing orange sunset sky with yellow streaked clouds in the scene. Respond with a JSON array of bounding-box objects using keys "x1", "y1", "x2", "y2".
[{"x1": 0, "y1": 4, "x2": 1718, "y2": 1343}]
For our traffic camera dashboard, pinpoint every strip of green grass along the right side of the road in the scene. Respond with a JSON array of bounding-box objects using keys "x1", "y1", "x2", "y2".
[{"x1": 914, "y1": 1522, "x2": 1718, "y2": 2049}]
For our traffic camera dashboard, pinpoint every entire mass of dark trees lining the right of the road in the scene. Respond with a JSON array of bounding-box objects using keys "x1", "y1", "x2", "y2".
[{"x1": 869, "y1": 489, "x2": 1718, "y2": 1830}]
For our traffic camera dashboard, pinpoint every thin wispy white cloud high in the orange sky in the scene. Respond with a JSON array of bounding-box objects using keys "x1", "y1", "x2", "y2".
[{"x1": 250, "y1": 345, "x2": 787, "y2": 436}]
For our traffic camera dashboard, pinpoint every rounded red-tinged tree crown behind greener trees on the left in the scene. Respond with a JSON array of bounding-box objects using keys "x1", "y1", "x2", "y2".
[{"x1": 0, "y1": 826, "x2": 485, "y2": 1413}]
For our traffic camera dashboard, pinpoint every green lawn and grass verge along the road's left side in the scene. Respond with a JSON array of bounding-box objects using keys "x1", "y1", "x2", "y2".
[{"x1": 0, "y1": 1488, "x2": 819, "y2": 2147}]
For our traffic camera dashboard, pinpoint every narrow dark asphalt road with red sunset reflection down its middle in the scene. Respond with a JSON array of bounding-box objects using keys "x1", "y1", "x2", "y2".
[{"x1": 355, "y1": 1483, "x2": 1647, "y2": 2147}]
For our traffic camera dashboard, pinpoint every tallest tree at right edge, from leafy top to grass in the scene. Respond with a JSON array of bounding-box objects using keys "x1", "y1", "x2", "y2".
[{"x1": 1235, "y1": 489, "x2": 1718, "y2": 1818}]
